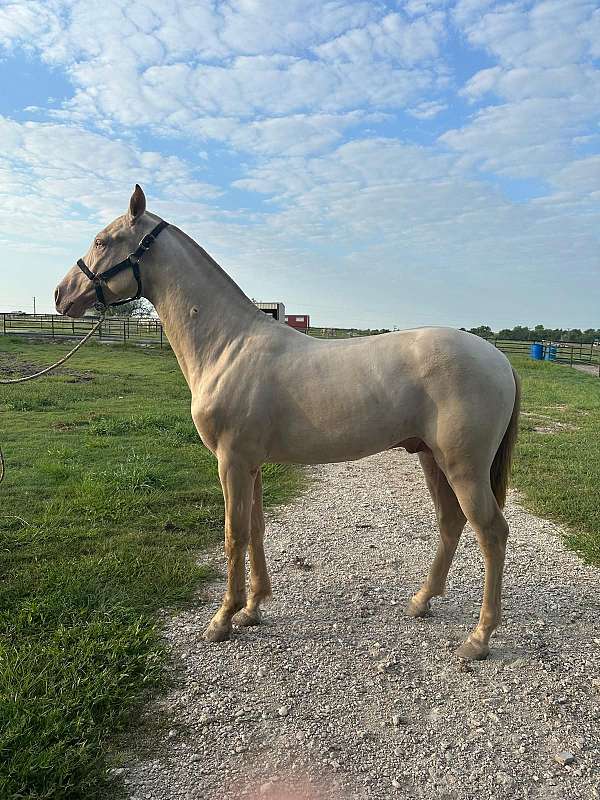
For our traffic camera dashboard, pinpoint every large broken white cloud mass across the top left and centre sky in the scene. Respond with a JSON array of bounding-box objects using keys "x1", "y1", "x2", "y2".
[{"x1": 0, "y1": 0, "x2": 445, "y2": 152}]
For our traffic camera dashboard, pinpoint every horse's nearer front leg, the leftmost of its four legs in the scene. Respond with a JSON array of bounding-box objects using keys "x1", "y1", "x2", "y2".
[{"x1": 204, "y1": 456, "x2": 257, "y2": 642}]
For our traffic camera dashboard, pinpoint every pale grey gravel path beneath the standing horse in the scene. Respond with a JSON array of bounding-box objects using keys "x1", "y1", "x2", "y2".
[{"x1": 117, "y1": 451, "x2": 600, "y2": 800}]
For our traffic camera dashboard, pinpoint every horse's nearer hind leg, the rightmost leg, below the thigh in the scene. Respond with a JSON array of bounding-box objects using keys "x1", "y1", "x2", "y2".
[{"x1": 450, "y1": 470, "x2": 508, "y2": 659}]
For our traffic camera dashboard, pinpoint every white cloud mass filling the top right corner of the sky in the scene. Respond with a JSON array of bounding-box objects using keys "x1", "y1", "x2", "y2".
[{"x1": 440, "y1": 0, "x2": 600, "y2": 180}]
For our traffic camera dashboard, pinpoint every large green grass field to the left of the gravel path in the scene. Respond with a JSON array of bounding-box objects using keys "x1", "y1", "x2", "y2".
[{"x1": 0, "y1": 337, "x2": 300, "y2": 800}]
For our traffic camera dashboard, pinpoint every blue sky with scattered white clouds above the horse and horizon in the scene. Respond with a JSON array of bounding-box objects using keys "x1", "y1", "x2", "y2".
[{"x1": 0, "y1": 0, "x2": 600, "y2": 330}]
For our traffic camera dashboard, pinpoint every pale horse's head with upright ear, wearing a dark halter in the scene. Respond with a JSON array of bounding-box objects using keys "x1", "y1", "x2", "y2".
[{"x1": 54, "y1": 184, "x2": 155, "y2": 317}]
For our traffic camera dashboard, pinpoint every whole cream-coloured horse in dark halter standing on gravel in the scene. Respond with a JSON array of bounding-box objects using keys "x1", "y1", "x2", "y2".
[{"x1": 55, "y1": 186, "x2": 519, "y2": 658}]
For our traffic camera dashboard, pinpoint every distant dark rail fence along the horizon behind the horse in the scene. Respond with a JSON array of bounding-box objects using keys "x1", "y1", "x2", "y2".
[{"x1": 0, "y1": 314, "x2": 600, "y2": 376}]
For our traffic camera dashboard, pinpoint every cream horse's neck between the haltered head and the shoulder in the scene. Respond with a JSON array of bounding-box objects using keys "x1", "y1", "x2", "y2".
[{"x1": 144, "y1": 228, "x2": 268, "y2": 391}]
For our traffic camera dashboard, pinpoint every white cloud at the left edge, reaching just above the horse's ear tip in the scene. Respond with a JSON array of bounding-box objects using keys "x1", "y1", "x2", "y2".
[{"x1": 0, "y1": 117, "x2": 220, "y2": 244}]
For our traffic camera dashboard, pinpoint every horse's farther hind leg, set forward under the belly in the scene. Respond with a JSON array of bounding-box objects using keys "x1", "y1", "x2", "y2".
[{"x1": 406, "y1": 452, "x2": 466, "y2": 617}]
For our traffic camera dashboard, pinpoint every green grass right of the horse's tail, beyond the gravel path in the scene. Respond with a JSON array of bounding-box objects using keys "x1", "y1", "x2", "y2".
[{"x1": 512, "y1": 357, "x2": 600, "y2": 564}]
